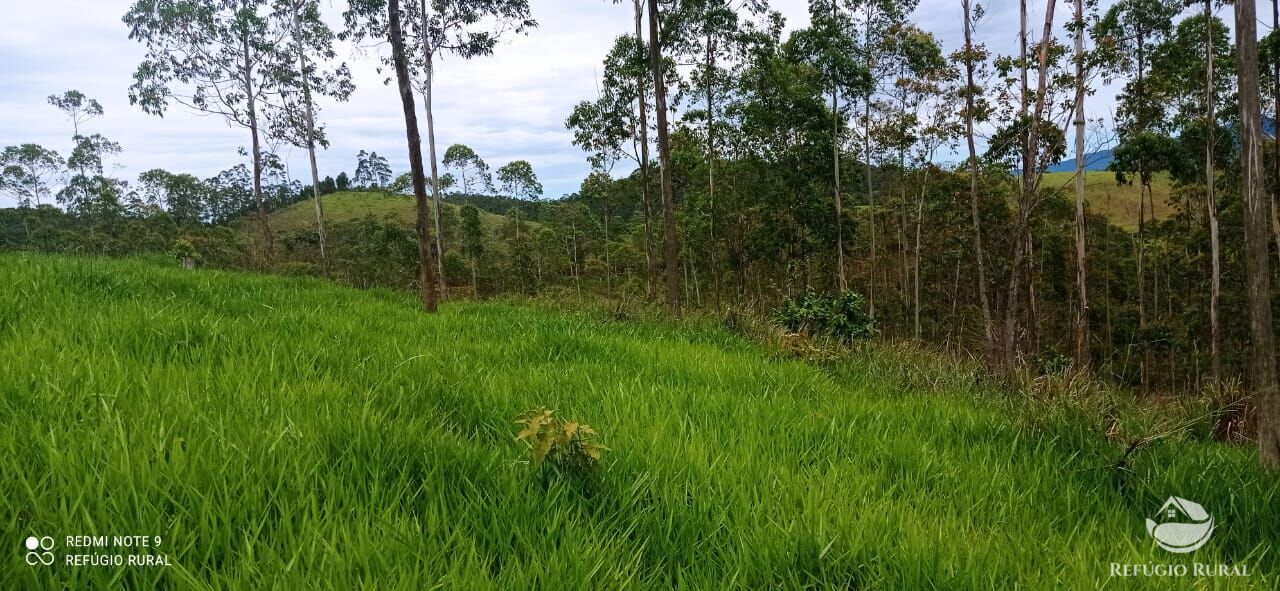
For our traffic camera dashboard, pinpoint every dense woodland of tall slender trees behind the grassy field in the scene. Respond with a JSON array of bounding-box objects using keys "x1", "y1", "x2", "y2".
[{"x1": 0, "y1": 0, "x2": 1280, "y2": 463}]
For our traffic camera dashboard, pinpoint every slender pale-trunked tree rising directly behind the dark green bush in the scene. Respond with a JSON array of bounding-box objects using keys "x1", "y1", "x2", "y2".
[{"x1": 792, "y1": 0, "x2": 873, "y2": 292}]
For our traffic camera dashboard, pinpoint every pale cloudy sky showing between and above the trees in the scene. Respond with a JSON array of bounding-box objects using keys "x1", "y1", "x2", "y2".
[{"x1": 0, "y1": 0, "x2": 1270, "y2": 206}]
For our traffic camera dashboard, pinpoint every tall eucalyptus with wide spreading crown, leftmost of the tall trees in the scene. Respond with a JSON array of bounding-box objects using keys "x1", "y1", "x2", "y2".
[{"x1": 124, "y1": 0, "x2": 284, "y2": 255}]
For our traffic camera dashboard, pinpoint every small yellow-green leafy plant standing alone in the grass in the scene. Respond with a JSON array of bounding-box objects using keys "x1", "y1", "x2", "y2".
[{"x1": 516, "y1": 407, "x2": 609, "y2": 475}]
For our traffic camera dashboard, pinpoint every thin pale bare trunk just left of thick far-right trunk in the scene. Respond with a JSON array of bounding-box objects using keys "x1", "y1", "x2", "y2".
[{"x1": 1204, "y1": 0, "x2": 1222, "y2": 385}]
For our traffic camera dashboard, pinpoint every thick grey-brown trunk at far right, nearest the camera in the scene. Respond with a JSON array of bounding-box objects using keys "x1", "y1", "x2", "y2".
[{"x1": 1235, "y1": 1, "x2": 1280, "y2": 468}]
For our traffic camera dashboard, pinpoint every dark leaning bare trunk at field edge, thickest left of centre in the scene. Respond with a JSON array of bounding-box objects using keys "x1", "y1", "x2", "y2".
[{"x1": 387, "y1": 0, "x2": 436, "y2": 312}]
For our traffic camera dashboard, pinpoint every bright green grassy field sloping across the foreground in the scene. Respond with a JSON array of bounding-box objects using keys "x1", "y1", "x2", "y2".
[{"x1": 0, "y1": 253, "x2": 1280, "y2": 590}]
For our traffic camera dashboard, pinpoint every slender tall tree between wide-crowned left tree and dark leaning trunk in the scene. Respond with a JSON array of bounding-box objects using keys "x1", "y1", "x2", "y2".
[{"x1": 269, "y1": 0, "x2": 355, "y2": 276}]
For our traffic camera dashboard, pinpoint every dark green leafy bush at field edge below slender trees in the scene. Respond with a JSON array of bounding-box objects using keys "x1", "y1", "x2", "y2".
[{"x1": 773, "y1": 290, "x2": 876, "y2": 344}]
